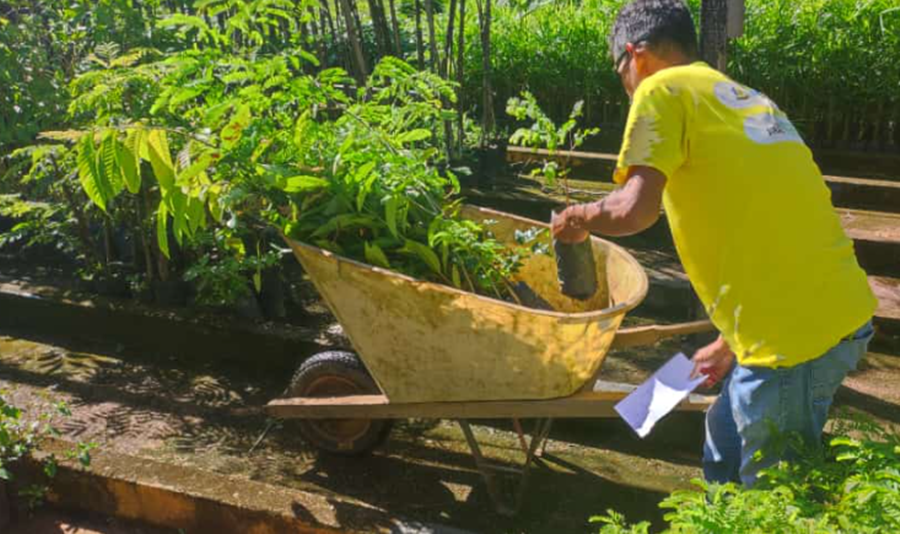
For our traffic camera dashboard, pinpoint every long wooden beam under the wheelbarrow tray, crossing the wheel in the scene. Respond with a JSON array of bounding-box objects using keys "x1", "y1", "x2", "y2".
[{"x1": 266, "y1": 384, "x2": 715, "y2": 419}]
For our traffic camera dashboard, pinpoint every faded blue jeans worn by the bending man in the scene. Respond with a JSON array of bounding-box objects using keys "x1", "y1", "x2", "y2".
[{"x1": 703, "y1": 321, "x2": 875, "y2": 487}]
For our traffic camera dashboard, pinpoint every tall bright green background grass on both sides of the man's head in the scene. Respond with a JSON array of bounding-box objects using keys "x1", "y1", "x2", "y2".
[{"x1": 465, "y1": 0, "x2": 900, "y2": 150}]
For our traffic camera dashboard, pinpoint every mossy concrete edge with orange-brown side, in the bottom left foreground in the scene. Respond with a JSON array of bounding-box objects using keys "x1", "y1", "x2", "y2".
[{"x1": 16, "y1": 440, "x2": 460, "y2": 534}]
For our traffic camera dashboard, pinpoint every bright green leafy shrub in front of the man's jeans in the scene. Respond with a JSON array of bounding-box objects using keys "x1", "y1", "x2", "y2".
[{"x1": 591, "y1": 422, "x2": 900, "y2": 534}]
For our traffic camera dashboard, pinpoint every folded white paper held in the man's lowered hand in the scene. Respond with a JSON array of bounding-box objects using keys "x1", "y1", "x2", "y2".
[{"x1": 616, "y1": 353, "x2": 706, "y2": 438}]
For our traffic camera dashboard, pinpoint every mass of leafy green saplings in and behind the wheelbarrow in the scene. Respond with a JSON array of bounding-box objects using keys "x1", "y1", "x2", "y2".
[{"x1": 7, "y1": 4, "x2": 525, "y2": 308}]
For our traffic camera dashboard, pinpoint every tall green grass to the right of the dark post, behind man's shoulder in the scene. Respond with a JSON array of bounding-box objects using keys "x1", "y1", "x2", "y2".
[{"x1": 729, "y1": 0, "x2": 900, "y2": 146}]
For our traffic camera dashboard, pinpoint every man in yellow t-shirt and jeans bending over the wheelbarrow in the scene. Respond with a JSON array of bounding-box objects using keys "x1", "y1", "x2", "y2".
[{"x1": 553, "y1": 0, "x2": 876, "y2": 486}]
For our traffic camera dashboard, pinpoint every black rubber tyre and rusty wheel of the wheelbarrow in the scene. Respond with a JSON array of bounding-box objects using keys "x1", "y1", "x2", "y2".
[{"x1": 288, "y1": 351, "x2": 393, "y2": 456}]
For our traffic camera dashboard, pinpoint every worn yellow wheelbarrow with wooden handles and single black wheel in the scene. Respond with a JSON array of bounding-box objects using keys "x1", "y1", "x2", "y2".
[{"x1": 266, "y1": 207, "x2": 712, "y2": 514}]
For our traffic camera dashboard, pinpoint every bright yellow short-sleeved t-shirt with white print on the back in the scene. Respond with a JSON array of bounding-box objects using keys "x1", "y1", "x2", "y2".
[{"x1": 615, "y1": 62, "x2": 877, "y2": 367}]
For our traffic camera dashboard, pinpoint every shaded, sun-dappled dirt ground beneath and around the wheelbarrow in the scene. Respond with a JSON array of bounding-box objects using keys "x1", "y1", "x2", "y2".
[{"x1": 0, "y1": 319, "x2": 900, "y2": 533}]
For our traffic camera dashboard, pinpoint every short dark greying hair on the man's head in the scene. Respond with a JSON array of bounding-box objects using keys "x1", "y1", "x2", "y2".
[{"x1": 609, "y1": 0, "x2": 698, "y2": 61}]
